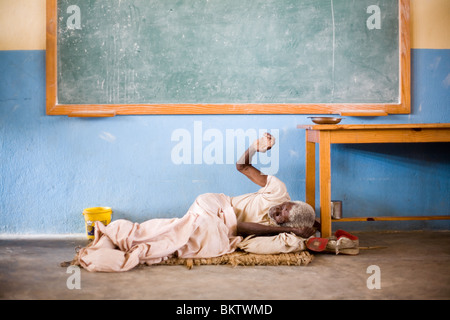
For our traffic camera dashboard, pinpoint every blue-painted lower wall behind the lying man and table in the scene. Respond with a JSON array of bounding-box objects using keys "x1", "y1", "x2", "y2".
[{"x1": 0, "y1": 49, "x2": 450, "y2": 234}]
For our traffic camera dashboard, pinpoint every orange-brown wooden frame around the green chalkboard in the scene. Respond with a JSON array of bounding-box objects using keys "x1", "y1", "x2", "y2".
[{"x1": 46, "y1": 0, "x2": 411, "y2": 117}]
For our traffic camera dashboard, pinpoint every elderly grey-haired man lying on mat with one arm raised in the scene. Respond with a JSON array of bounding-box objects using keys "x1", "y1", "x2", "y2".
[{"x1": 78, "y1": 133, "x2": 318, "y2": 272}]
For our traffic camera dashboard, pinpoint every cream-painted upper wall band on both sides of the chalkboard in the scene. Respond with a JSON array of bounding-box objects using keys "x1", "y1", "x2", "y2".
[{"x1": 0, "y1": 0, "x2": 450, "y2": 50}]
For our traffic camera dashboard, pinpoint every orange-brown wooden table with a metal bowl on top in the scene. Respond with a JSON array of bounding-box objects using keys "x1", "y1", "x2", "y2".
[{"x1": 297, "y1": 123, "x2": 450, "y2": 237}]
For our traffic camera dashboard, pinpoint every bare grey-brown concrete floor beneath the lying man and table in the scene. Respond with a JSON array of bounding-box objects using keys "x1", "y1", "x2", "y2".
[{"x1": 0, "y1": 231, "x2": 450, "y2": 300}]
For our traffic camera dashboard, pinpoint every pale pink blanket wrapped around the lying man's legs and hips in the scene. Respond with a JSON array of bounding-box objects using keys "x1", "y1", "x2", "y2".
[{"x1": 78, "y1": 193, "x2": 242, "y2": 272}]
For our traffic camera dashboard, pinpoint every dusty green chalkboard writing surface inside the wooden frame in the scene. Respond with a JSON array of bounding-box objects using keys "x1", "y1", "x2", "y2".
[{"x1": 48, "y1": 0, "x2": 408, "y2": 115}]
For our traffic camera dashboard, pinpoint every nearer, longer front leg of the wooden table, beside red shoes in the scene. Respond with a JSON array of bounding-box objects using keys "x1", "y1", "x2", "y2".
[{"x1": 319, "y1": 131, "x2": 331, "y2": 238}]
